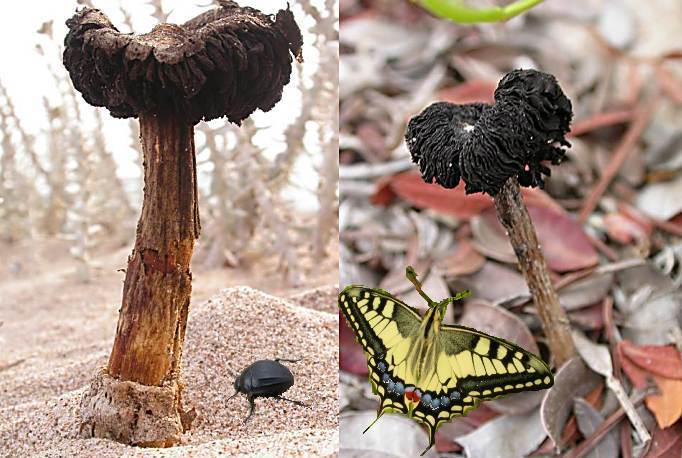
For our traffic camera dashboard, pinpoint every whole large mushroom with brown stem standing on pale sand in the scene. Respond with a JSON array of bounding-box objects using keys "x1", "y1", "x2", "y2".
[{"x1": 64, "y1": 0, "x2": 302, "y2": 446}]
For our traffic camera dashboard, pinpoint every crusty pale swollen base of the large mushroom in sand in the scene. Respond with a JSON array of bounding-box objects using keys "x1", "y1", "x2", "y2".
[{"x1": 80, "y1": 372, "x2": 193, "y2": 447}]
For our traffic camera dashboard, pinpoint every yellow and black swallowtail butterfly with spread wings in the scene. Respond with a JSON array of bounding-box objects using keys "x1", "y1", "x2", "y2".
[{"x1": 339, "y1": 270, "x2": 553, "y2": 453}]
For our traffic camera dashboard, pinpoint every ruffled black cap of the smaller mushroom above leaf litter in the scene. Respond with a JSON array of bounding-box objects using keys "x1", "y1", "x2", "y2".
[{"x1": 405, "y1": 70, "x2": 573, "y2": 196}]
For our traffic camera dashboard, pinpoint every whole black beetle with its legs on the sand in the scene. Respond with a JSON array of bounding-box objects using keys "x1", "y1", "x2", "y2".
[{"x1": 226, "y1": 358, "x2": 307, "y2": 423}]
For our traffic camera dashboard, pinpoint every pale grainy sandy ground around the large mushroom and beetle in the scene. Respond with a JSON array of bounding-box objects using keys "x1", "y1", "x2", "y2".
[{"x1": 0, "y1": 242, "x2": 338, "y2": 457}]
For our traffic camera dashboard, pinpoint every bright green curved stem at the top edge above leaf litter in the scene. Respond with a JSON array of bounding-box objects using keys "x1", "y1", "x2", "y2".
[{"x1": 415, "y1": 0, "x2": 544, "y2": 24}]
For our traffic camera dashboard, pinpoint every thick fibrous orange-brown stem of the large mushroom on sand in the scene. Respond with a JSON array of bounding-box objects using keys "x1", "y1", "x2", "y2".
[{"x1": 108, "y1": 110, "x2": 200, "y2": 386}]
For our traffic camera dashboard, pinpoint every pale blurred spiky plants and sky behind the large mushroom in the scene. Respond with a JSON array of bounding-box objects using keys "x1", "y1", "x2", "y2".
[{"x1": 0, "y1": 0, "x2": 338, "y2": 286}]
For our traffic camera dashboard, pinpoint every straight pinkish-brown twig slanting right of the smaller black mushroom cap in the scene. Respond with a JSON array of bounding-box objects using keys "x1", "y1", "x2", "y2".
[{"x1": 578, "y1": 95, "x2": 659, "y2": 223}]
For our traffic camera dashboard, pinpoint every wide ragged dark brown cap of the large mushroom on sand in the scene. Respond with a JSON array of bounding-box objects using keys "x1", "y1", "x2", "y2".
[{"x1": 64, "y1": 0, "x2": 303, "y2": 124}]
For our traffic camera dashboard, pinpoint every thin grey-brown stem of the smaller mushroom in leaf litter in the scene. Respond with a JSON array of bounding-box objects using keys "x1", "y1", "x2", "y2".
[{"x1": 494, "y1": 176, "x2": 576, "y2": 367}]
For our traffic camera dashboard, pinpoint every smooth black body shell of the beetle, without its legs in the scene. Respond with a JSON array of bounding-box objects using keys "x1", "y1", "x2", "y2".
[{"x1": 235, "y1": 360, "x2": 294, "y2": 397}]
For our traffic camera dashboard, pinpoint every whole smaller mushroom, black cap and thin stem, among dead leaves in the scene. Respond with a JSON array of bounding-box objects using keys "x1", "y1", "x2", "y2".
[{"x1": 405, "y1": 70, "x2": 575, "y2": 367}]
